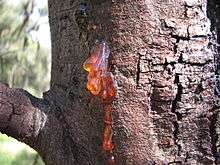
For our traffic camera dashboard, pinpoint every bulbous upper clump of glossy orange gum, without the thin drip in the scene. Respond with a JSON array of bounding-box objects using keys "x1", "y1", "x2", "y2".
[{"x1": 83, "y1": 42, "x2": 116, "y2": 102}]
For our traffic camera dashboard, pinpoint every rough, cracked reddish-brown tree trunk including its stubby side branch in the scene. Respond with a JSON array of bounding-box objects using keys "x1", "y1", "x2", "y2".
[{"x1": 0, "y1": 0, "x2": 220, "y2": 165}]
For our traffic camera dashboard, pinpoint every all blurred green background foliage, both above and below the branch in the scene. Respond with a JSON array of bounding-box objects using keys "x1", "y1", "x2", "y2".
[{"x1": 0, "y1": 0, "x2": 50, "y2": 165}]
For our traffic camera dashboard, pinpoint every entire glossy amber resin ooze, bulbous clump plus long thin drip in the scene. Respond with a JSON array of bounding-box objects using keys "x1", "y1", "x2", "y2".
[{"x1": 83, "y1": 41, "x2": 116, "y2": 165}]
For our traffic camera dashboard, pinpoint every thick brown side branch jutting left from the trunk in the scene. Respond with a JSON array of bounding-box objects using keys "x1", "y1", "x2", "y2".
[{"x1": 0, "y1": 83, "x2": 49, "y2": 146}]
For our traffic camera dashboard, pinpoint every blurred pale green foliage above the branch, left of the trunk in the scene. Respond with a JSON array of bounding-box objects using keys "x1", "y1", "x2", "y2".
[{"x1": 0, "y1": 1, "x2": 49, "y2": 96}]
